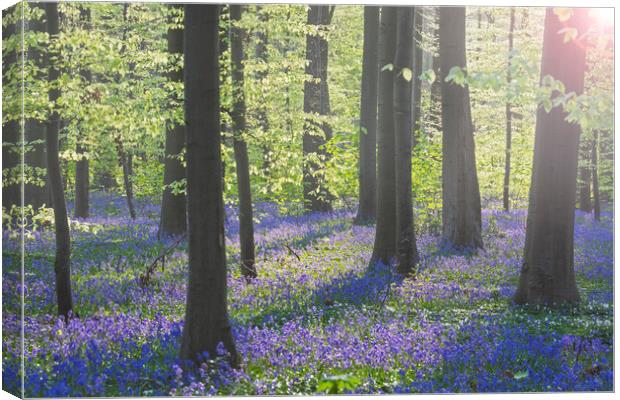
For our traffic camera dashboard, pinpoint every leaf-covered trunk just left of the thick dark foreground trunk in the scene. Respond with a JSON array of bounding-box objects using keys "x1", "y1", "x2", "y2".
[{"x1": 158, "y1": 4, "x2": 187, "y2": 238}]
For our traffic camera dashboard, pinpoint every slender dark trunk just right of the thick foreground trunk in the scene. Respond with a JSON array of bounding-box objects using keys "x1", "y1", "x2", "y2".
[{"x1": 230, "y1": 4, "x2": 256, "y2": 278}]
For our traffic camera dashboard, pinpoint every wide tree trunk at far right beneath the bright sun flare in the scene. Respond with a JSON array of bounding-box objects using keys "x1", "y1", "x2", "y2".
[{"x1": 515, "y1": 8, "x2": 587, "y2": 305}]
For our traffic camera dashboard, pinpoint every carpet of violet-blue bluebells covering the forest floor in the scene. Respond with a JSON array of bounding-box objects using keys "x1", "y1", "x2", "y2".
[{"x1": 2, "y1": 194, "x2": 613, "y2": 397}]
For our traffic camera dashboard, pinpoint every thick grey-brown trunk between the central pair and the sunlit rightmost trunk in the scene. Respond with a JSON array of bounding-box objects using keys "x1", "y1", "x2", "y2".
[{"x1": 439, "y1": 7, "x2": 482, "y2": 248}]
